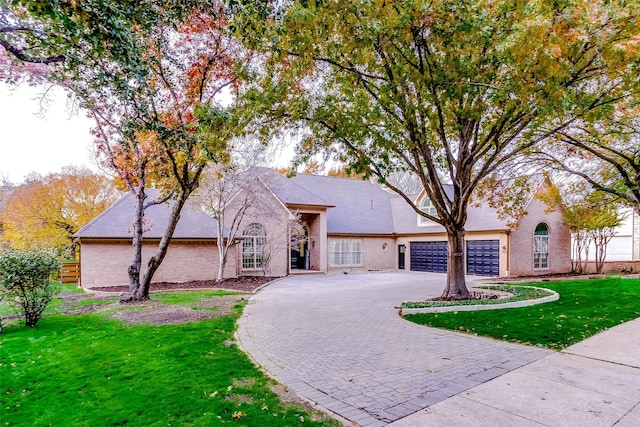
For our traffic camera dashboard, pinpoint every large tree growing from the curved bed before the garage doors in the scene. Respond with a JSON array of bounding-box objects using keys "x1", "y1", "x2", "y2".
[{"x1": 240, "y1": 0, "x2": 640, "y2": 298}]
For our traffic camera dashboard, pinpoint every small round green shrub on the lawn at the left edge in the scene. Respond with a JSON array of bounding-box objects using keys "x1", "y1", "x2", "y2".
[{"x1": 0, "y1": 249, "x2": 60, "y2": 327}]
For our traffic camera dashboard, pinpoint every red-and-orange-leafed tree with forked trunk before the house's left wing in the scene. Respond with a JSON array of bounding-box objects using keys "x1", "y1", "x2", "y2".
[{"x1": 88, "y1": 13, "x2": 250, "y2": 300}]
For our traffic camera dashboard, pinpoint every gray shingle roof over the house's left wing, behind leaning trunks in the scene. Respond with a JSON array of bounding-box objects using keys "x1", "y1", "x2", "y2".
[{"x1": 74, "y1": 189, "x2": 217, "y2": 239}]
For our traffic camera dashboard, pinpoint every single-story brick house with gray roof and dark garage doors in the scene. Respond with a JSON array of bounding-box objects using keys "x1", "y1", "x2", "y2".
[{"x1": 76, "y1": 168, "x2": 571, "y2": 287}]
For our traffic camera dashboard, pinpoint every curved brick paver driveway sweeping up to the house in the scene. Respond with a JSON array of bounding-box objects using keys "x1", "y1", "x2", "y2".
[{"x1": 238, "y1": 273, "x2": 551, "y2": 426}]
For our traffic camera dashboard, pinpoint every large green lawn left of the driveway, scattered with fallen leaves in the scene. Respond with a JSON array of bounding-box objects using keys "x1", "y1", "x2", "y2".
[{"x1": 0, "y1": 292, "x2": 336, "y2": 426}]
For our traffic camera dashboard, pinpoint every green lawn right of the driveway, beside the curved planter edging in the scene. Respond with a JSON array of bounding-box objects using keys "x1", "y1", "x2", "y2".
[{"x1": 405, "y1": 278, "x2": 640, "y2": 350}]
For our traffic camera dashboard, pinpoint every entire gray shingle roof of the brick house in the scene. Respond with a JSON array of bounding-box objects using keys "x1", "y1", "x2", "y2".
[{"x1": 75, "y1": 168, "x2": 508, "y2": 239}]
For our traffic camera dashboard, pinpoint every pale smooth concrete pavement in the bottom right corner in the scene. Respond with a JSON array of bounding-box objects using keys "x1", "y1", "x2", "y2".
[{"x1": 391, "y1": 318, "x2": 640, "y2": 427}]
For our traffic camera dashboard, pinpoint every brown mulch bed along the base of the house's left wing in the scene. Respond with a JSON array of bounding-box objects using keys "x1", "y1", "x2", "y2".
[{"x1": 89, "y1": 277, "x2": 276, "y2": 293}]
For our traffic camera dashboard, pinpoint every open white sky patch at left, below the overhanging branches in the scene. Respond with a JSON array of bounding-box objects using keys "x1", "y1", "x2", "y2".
[{"x1": 0, "y1": 82, "x2": 98, "y2": 184}]
